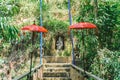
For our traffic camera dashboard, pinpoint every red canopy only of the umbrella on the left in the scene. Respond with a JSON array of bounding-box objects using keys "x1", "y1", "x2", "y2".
[{"x1": 21, "y1": 24, "x2": 48, "y2": 32}]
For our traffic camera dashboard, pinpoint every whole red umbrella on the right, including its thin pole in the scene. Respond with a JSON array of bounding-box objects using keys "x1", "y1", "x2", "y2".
[{"x1": 69, "y1": 22, "x2": 97, "y2": 75}]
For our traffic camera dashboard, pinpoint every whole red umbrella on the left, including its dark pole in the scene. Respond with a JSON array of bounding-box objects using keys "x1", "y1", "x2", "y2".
[{"x1": 21, "y1": 22, "x2": 48, "y2": 78}]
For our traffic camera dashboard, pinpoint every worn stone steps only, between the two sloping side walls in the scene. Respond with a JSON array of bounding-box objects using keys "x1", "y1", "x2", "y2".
[{"x1": 43, "y1": 63, "x2": 71, "y2": 80}]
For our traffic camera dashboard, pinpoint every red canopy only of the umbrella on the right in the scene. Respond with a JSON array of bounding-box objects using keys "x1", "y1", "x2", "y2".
[{"x1": 69, "y1": 22, "x2": 97, "y2": 29}]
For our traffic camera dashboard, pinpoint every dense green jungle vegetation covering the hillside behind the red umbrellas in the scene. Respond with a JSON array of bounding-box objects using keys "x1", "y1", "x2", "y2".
[{"x1": 0, "y1": 0, "x2": 120, "y2": 80}]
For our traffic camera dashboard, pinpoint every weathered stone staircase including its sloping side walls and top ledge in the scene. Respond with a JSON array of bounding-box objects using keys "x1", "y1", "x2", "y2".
[{"x1": 13, "y1": 56, "x2": 103, "y2": 80}]
